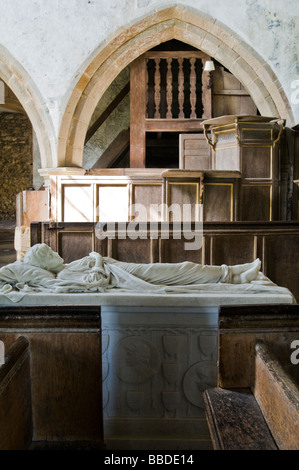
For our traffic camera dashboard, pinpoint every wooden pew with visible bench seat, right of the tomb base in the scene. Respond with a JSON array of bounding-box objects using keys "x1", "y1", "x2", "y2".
[{"x1": 204, "y1": 305, "x2": 299, "y2": 450}]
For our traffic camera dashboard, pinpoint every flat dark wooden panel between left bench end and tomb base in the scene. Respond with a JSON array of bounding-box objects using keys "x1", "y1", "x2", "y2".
[{"x1": 31, "y1": 332, "x2": 101, "y2": 441}]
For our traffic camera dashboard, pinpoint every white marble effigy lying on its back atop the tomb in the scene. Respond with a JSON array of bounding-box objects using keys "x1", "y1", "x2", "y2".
[{"x1": 0, "y1": 243, "x2": 271, "y2": 294}]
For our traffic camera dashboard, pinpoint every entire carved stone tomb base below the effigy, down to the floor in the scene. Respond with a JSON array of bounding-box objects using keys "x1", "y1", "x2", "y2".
[{"x1": 102, "y1": 306, "x2": 218, "y2": 450}]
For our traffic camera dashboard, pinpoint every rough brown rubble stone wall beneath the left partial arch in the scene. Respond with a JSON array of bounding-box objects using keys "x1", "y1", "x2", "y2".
[{"x1": 0, "y1": 113, "x2": 32, "y2": 220}]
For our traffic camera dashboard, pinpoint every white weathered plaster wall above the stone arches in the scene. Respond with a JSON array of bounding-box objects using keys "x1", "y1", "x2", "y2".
[{"x1": 0, "y1": 0, "x2": 299, "y2": 135}]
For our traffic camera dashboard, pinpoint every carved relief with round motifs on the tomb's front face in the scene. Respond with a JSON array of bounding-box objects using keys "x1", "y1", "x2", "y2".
[{"x1": 102, "y1": 308, "x2": 217, "y2": 426}]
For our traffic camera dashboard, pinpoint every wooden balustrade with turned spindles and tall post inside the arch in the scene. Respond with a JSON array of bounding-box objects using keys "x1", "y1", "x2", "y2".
[{"x1": 130, "y1": 51, "x2": 212, "y2": 168}]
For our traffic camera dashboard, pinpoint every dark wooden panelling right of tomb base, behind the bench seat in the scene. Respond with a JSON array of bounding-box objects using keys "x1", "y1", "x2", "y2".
[{"x1": 218, "y1": 305, "x2": 299, "y2": 388}]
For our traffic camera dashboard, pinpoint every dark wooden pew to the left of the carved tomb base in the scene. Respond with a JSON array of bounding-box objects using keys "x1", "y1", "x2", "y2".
[{"x1": 0, "y1": 305, "x2": 104, "y2": 450}]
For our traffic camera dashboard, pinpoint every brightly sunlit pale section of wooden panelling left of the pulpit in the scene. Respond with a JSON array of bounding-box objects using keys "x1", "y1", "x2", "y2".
[{"x1": 51, "y1": 173, "x2": 202, "y2": 223}]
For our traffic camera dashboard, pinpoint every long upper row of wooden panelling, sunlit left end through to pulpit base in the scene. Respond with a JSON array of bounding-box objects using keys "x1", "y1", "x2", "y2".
[{"x1": 51, "y1": 168, "x2": 283, "y2": 222}]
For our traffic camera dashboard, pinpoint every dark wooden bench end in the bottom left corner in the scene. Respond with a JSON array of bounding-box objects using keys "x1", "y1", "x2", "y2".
[{"x1": 0, "y1": 336, "x2": 33, "y2": 450}]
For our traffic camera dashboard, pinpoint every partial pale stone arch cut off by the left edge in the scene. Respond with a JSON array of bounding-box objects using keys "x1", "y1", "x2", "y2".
[{"x1": 0, "y1": 46, "x2": 57, "y2": 168}]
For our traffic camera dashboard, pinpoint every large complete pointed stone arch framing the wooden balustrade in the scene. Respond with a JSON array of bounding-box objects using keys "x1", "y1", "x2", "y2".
[{"x1": 58, "y1": 6, "x2": 294, "y2": 168}]
